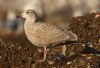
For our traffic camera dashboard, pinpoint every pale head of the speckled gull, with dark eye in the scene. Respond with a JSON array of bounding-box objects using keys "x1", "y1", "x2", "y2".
[{"x1": 22, "y1": 9, "x2": 37, "y2": 19}]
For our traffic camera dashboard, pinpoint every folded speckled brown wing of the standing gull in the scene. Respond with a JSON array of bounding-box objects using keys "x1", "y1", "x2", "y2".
[{"x1": 32, "y1": 23, "x2": 77, "y2": 45}]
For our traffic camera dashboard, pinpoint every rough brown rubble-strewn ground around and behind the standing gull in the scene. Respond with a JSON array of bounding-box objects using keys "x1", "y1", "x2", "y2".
[{"x1": 0, "y1": 13, "x2": 100, "y2": 68}]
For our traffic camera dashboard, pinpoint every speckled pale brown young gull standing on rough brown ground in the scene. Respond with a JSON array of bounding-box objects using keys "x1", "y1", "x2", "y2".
[{"x1": 22, "y1": 9, "x2": 77, "y2": 61}]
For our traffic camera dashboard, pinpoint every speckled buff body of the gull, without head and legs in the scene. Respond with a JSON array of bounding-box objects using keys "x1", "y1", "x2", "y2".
[{"x1": 25, "y1": 22, "x2": 77, "y2": 47}]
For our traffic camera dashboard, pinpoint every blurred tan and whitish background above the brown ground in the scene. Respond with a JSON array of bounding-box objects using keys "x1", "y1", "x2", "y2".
[{"x1": 0, "y1": 0, "x2": 100, "y2": 36}]
